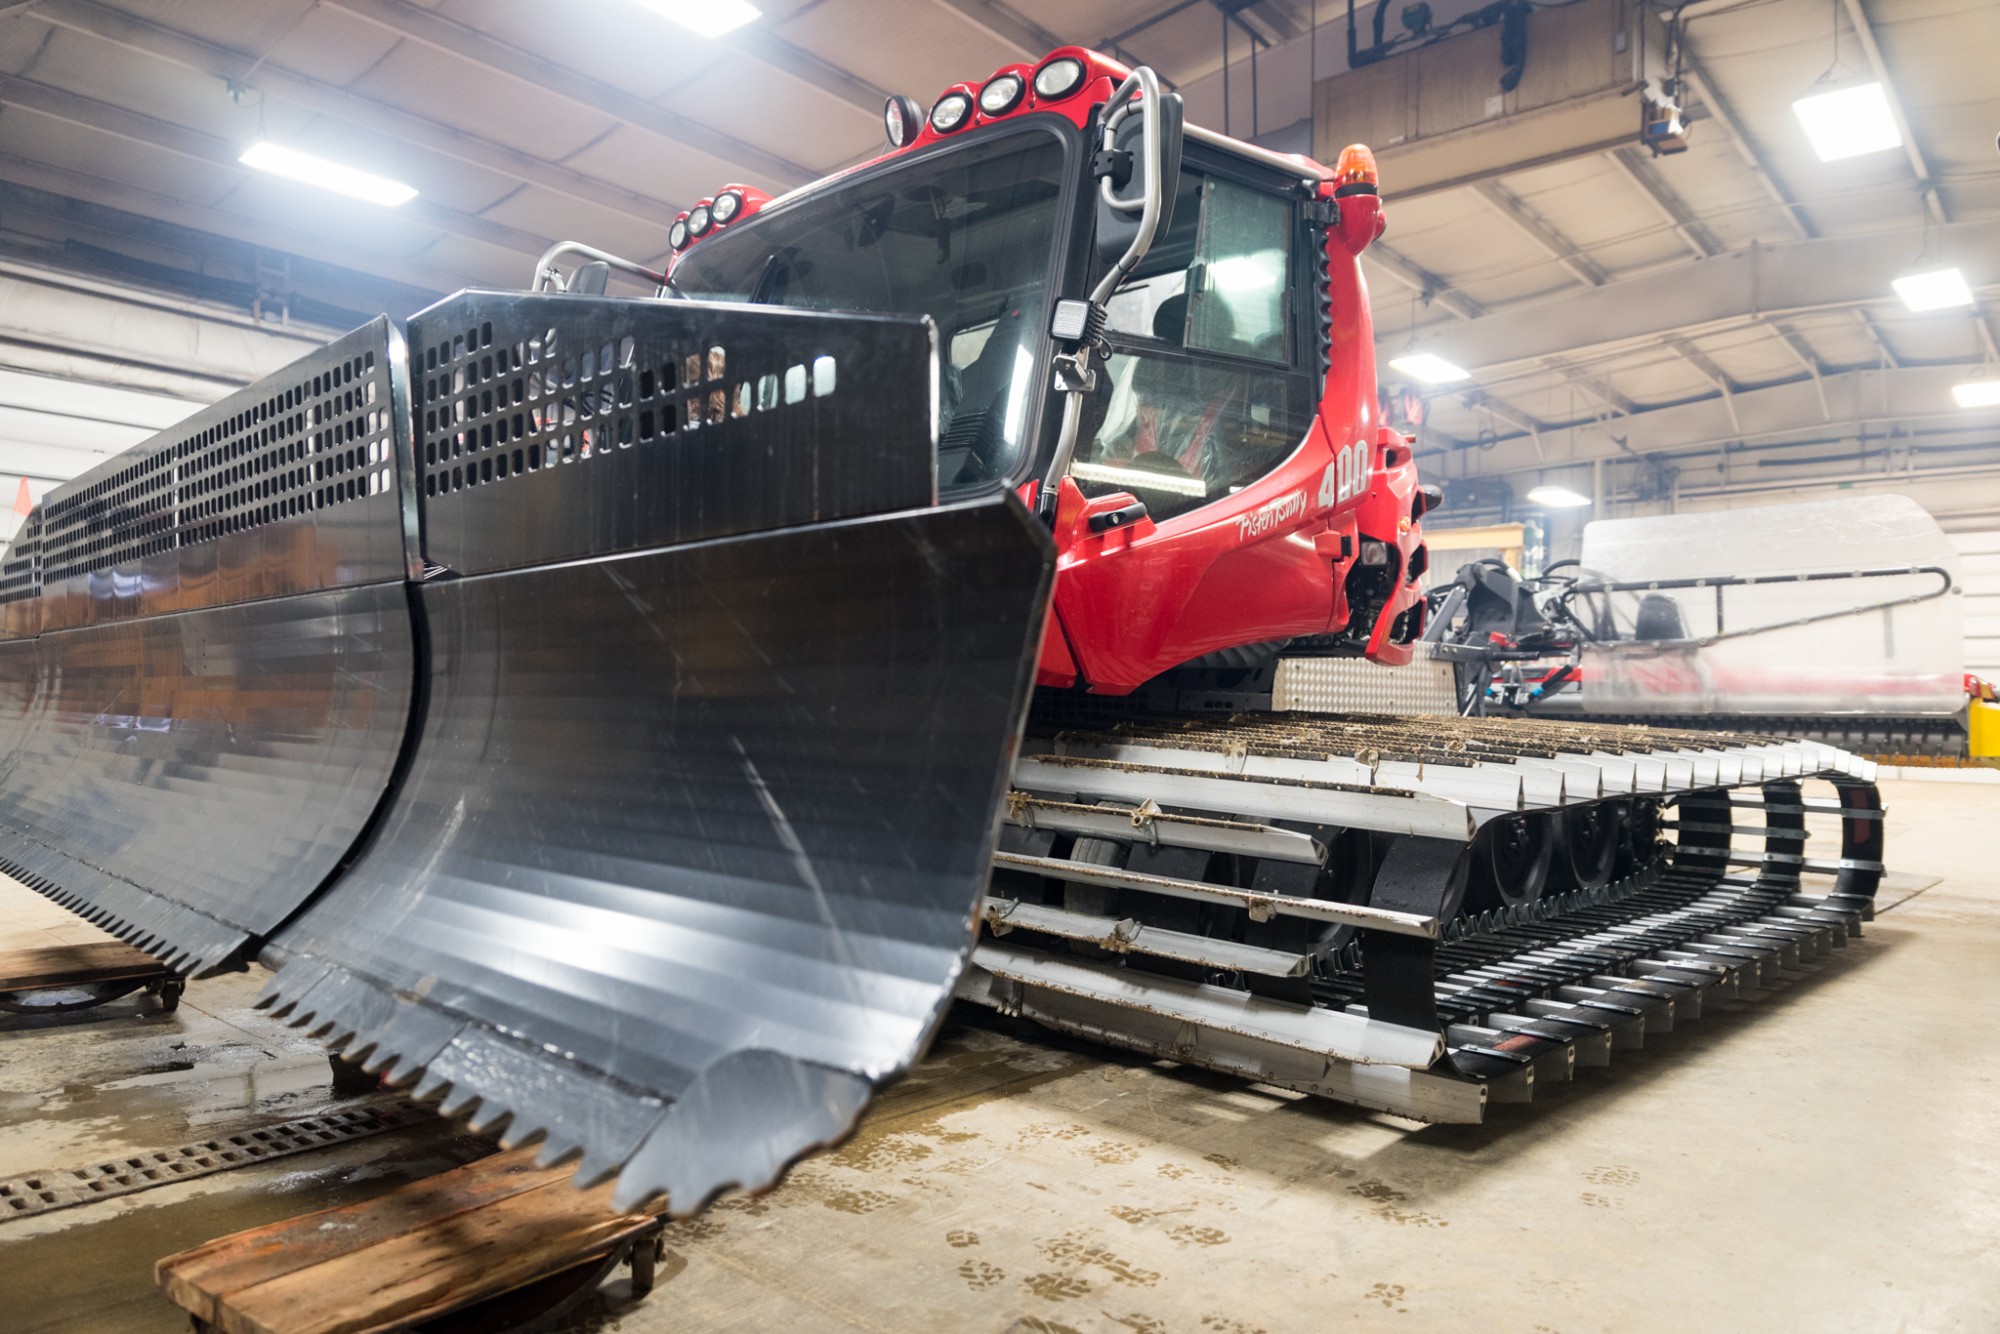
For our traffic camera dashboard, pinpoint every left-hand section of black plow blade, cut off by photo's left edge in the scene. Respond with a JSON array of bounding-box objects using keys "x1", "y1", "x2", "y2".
[{"x1": 0, "y1": 320, "x2": 416, "y2": 972}]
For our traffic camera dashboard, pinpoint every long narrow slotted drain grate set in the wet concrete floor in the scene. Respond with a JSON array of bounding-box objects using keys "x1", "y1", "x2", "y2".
[{"x1": 0, "y1": 1098, "x2": 430, "y2": 1224}]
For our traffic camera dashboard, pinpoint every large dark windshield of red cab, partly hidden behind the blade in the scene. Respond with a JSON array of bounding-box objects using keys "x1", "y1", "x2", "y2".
[{"x1": 674, "y1": 132, "x2": 1066, "y2": 494}]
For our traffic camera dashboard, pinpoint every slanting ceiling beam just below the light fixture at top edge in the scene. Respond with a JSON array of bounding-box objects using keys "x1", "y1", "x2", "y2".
[{"x1": 324, "y1": 0, "x2": 820, "y2": 186}]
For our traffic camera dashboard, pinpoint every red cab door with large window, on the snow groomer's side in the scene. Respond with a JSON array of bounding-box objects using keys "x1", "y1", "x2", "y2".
[{"x1": 1056, "y1": 154, "x2": 1338, "y2": 694}]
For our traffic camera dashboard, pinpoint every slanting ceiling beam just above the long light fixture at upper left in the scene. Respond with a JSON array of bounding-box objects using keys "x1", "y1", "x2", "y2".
[{"x1": 34, "y1": 0, "x2": 676, "y2": 230}]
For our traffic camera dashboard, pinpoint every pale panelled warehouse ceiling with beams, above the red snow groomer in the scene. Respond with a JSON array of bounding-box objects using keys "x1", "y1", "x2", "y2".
[{"x1": 0, "y1": 0, "x2": 2000, "y2": 512}]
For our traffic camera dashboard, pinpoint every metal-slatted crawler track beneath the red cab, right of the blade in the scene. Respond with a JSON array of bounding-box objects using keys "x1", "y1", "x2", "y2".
[{"x1": 960, "y1": 714, "x2": 1882, "y2": 1122}]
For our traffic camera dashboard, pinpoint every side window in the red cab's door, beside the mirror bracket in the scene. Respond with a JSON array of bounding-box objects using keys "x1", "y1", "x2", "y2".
[{"x1": 1070, "y1": 170, "x2": 1312, "y2": 520}]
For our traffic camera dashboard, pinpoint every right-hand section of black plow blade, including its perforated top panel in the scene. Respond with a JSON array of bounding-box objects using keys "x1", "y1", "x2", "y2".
[{"x1": 266, "y1": 294, "x2": 1054, "y2": 1214}]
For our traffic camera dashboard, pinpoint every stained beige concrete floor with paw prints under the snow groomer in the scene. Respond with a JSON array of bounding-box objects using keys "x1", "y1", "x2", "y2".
[{"x1": 0, "y1": 782, "x2": 2000, "y2": 1334}]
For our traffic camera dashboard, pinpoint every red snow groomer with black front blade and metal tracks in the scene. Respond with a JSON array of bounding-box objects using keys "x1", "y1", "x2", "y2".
[{"x1": 0, "y1": 48, "x2": 1880, "y2": 1214}]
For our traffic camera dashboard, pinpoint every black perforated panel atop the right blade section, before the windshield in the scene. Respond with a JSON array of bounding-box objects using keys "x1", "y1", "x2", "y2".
[{"x1": 410, "y1": 292, "x2": 936, "y2": 574}]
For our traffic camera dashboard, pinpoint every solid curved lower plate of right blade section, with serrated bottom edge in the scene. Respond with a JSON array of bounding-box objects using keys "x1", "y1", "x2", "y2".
[{"x1": 268, "y1": 498, "x2": 1050, "y2": 1214}]
